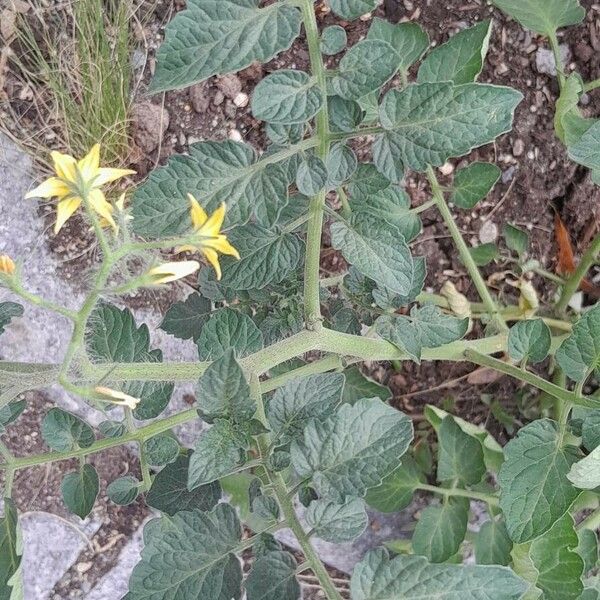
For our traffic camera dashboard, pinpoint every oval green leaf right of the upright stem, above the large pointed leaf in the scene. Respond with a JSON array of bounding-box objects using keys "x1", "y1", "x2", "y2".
[{"x1": 331, "y1": 39, "x2": 400, "y2": 100}]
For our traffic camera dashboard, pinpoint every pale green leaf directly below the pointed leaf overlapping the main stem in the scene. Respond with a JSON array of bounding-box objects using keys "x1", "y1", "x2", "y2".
[{"x1": 188, "y1": 420, "x2": 245, "y2": 491}]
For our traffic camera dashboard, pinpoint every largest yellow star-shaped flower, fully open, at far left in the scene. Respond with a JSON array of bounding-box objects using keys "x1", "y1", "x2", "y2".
[{"x1": 25, "y1": 144, "x2": 135, "y2": 233}]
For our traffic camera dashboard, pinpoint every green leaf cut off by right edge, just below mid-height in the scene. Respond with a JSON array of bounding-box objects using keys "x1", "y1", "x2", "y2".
[{"x1": 556, "y1": 304, "x2": 600, "y2": 382}]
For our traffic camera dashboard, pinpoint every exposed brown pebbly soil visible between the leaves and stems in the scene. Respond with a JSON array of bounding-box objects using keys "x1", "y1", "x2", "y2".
[{"x1": 3, "y1": 0, "x2": 600, "y2": 598}]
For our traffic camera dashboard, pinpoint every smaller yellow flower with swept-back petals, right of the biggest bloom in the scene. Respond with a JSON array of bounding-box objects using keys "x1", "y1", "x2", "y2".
[{"x1": 177, "y1": 194, "x2": 240, "y2": 279}]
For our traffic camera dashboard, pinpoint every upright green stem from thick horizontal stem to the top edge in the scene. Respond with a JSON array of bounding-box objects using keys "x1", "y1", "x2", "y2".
[{"x1": 300, "y1": 0, "x2": 330, "y2": 329}]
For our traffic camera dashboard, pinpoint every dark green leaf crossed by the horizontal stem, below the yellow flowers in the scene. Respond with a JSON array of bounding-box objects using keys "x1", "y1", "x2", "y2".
[{"x1": 86, "y1": 303, "x2": 174, "y2": 419}]
